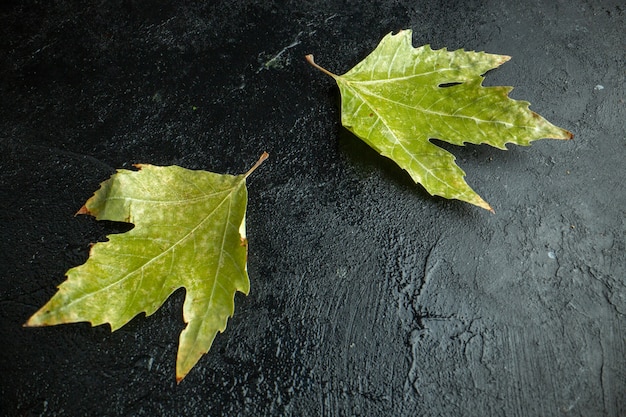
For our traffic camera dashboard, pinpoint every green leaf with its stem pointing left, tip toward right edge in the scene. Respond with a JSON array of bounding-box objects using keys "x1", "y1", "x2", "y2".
[{"x1": 307, "y1": 30, "x2": 573, "y2": 211}]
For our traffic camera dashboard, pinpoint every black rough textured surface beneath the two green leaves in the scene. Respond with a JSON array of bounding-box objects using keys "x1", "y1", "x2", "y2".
[{"x1": 0, "y1": 0, "x2": 626, "y2": 416}]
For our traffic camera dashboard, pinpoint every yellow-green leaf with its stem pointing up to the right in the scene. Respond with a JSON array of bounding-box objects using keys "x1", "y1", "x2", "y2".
[{"x1": 26, "y1": 153, "x2": 267, "y2": 381}]
